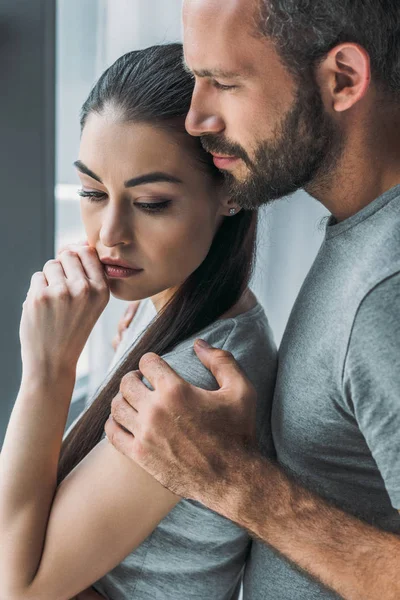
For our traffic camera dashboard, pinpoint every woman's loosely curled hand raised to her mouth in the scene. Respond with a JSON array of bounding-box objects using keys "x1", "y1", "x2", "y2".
[{"x1": 20, "y1": 242, "x2": 110, "y2": 377}]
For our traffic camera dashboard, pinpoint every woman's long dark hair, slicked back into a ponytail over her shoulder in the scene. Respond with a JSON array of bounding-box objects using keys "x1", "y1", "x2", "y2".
[{"x1": 57, "y1": 44, "x2": 257, "y2": 484}]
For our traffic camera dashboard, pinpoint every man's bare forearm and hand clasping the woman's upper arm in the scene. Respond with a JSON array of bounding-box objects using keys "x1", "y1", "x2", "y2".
[{"x1": 105, "y1": 300, "x2": 400, "y2": 600}]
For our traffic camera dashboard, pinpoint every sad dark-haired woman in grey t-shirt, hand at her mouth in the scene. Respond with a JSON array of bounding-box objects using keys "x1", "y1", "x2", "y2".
[{"x1": 0, "y1": 44, "x2": 276, "y2": 600}]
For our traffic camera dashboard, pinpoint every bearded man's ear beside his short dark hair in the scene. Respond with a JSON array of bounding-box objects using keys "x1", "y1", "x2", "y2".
[{"x1": 317, "y1": 43, "x2": 371, "y2": 112}]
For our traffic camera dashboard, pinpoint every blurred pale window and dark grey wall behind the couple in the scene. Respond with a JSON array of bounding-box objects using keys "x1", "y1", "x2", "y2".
[{"x1": 0, "y1": 0, "x2": 327, "y2": 446}]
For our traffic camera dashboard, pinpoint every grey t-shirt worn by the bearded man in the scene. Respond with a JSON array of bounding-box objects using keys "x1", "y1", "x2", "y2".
[{"x1": 244, "y1": 186, "x2": 400, "y2": 600}]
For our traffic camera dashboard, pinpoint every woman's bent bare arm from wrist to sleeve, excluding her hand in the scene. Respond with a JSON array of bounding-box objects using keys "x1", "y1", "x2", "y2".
[{"x1": 0, "y1": 379, "x2": 179, "y2": 600}]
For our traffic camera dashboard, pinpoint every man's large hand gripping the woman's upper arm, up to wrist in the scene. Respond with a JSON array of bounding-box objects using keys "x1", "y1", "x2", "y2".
[{"x1": 105, "y1": 343, "x2": 256, "y2": 500}]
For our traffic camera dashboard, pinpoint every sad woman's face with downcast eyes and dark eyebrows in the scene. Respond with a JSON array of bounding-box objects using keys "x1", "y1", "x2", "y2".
[{"x1": 75, "y1": 114, "x2": 232, "y2": 310}]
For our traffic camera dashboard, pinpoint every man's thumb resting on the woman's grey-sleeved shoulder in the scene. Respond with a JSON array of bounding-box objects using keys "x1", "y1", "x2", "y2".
[{"x1": 194, "y1": 340, "x2": 249, "y2": 393}]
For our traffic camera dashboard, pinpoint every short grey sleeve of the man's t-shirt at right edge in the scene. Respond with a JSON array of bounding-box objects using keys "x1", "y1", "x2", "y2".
[{"x1": 344, "y1": 273, "x2": 400, "y2": 509}]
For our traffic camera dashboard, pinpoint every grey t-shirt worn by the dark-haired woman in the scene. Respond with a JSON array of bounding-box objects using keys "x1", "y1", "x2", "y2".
[{"x1": 94, "y1": 304, "x2": 277, "y2": 600}]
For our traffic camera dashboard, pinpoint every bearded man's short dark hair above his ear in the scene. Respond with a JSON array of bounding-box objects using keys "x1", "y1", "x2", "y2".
[{"x1": 257, "y1": 0, "x2": 400, "y2": 96}]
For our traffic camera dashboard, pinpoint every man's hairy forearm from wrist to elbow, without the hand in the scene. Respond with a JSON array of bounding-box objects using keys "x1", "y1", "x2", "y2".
[{"x1": 206, "y1": 455, "x2": 400, "y2": 600}]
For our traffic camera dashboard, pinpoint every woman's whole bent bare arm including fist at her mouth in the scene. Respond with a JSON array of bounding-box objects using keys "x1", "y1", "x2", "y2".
[{"x1": 0, "y1": 247, "x2": 179, "y2": 600}]
